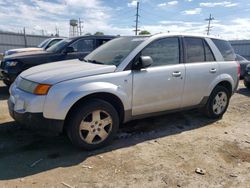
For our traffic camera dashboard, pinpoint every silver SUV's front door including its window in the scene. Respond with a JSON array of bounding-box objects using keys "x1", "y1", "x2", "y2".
[{"x1": 132, "y1": 37, "x2": 185, "y2": 116}]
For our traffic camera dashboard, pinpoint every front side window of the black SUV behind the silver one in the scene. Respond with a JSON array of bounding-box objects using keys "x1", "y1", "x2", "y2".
[{"x1": 70, "y1": 39, "x2": 94, "y2": 52}]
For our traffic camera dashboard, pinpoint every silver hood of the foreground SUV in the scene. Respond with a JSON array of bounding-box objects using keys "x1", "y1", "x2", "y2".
[{"x1": 20, "y1": 59, "x2": 116, "y2": 85}]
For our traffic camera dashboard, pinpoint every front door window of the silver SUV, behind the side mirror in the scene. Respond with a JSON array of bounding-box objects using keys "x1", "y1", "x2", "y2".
[{"x1": 141, "y1": 37, "x2": 180, "y2": 66}]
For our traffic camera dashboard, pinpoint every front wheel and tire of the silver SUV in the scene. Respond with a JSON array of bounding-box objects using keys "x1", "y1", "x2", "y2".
[{"x1": 66, "y1": 99, "x2": 119, "y2": 150}]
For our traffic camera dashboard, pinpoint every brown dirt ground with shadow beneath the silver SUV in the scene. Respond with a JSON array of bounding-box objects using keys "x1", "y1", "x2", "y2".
[{"x1": 0, "y1": 82, "x2": 250, "y2": 188}]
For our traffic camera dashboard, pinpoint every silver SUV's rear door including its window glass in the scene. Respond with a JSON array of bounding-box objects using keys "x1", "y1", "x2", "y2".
[{"x1": 182, "y1": 37, "x2": 218, "y2": 107}]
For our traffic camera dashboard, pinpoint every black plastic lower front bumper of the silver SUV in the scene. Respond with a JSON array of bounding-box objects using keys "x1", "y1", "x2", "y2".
[{"x1": 8, "y1": 99, "x2": 64, "y2": 133}]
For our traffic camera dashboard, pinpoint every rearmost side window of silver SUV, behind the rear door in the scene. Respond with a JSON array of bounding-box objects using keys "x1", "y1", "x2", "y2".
[{"x1": 212, "y1": 39, "x2": 235, "y2": 61}]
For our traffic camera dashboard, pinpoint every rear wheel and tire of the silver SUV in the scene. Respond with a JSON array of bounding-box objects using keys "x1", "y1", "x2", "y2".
[{"x1": 204, "y1": 86, "x2": 230, "y2": 119}]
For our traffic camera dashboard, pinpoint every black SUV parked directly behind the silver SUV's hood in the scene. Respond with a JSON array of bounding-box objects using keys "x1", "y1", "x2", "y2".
[{"x1": 0, "y1": 35, "x2": 114, "y2": 86}]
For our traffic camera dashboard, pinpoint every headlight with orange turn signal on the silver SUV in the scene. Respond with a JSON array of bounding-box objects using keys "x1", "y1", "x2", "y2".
[{"x1": 17, "y1": 79, "x2": 51, "y2": 95}]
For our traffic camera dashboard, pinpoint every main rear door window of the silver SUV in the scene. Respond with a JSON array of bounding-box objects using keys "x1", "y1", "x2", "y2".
[{"x1": 184, "y1": 37, "x2": 205, "y2": 63}]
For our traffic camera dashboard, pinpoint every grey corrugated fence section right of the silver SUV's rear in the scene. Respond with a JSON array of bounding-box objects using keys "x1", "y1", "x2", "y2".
[{"x1": 230, "y1": 40, "x2": 250, "y2": 60}]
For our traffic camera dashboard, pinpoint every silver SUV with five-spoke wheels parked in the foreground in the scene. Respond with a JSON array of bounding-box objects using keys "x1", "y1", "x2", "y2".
[{"x1": 8, "y1": 34, "x2": 240, "y2": 149}]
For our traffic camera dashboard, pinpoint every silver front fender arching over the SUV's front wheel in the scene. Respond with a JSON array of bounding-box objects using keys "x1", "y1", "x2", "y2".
[{"x1": 44, "y1": 82, "x2": 131, "y2": 120}]
